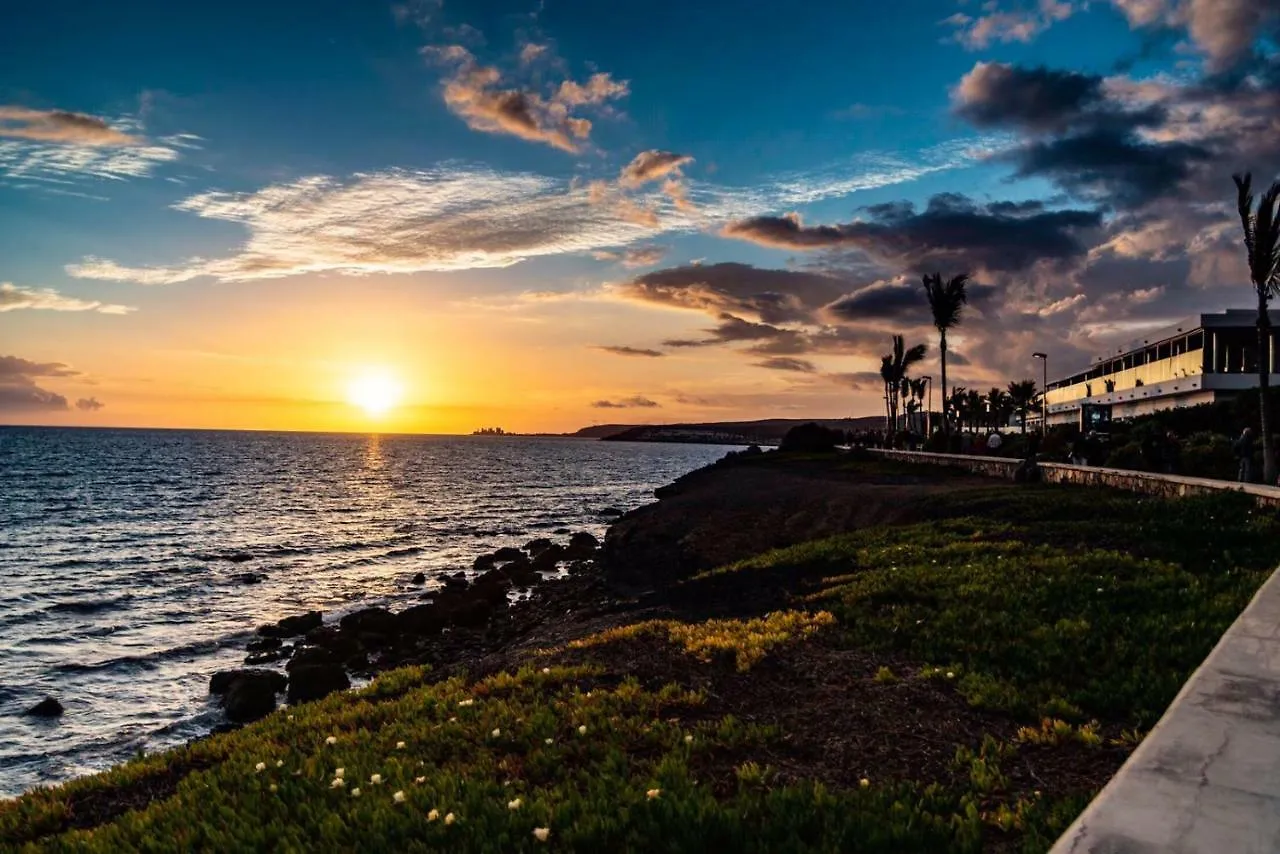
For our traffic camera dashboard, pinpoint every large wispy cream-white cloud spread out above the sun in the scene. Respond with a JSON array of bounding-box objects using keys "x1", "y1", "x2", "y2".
[{"x1": 67, "y1": 166, "x2": 689, "y2": 284}]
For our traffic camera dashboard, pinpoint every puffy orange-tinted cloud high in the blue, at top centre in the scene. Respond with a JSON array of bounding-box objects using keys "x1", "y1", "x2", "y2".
[{"x1": 422, "y1": 45, "x2": 628, "y2": 154}]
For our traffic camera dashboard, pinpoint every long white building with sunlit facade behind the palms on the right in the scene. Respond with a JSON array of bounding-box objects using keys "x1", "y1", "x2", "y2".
[{"x1": 1028, "y1": 309, "x2": 1280, "y2": 429}]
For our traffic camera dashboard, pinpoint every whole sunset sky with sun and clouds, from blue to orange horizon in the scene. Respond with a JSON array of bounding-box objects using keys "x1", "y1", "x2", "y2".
[{"x1": 0, "y1": 0, "x2": 1280, "y2": 433}]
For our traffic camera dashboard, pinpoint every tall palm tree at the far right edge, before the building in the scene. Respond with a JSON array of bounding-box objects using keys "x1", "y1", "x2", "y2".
[{"x1": 1231, "y1": 173, "x2": 1280, "y2": 484}]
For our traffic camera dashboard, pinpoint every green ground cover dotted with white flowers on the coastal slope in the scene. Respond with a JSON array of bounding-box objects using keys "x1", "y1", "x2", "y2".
[{"x1": 0, "y1": 463, "x2": 1280, "y2": 851}]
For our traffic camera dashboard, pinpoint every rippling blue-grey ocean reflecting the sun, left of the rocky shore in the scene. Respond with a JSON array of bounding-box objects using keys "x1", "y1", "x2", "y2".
[{"x1": 0, "y1": 428, "x2": 731, "y2": 796}]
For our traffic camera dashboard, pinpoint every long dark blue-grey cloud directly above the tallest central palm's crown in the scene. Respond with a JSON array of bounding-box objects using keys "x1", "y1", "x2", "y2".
[{"x1": 723, "y1": 193, "x2": 1102, "y2": 271}]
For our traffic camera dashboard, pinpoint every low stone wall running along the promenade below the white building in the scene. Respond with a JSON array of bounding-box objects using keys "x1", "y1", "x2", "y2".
[{"x1": 870, "y1": 448, "x2": 1280, "y2": 507}]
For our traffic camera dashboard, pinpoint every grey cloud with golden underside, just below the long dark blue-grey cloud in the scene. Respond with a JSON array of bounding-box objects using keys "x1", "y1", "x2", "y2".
[{"x1": 614, "y1": 264, "x2": 849, "y2": 324}]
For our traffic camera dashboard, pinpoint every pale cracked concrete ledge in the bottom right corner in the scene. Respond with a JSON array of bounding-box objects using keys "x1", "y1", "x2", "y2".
[{"x1": 1052, "y1": 563, "x2": 1280, "y2": 854}]
